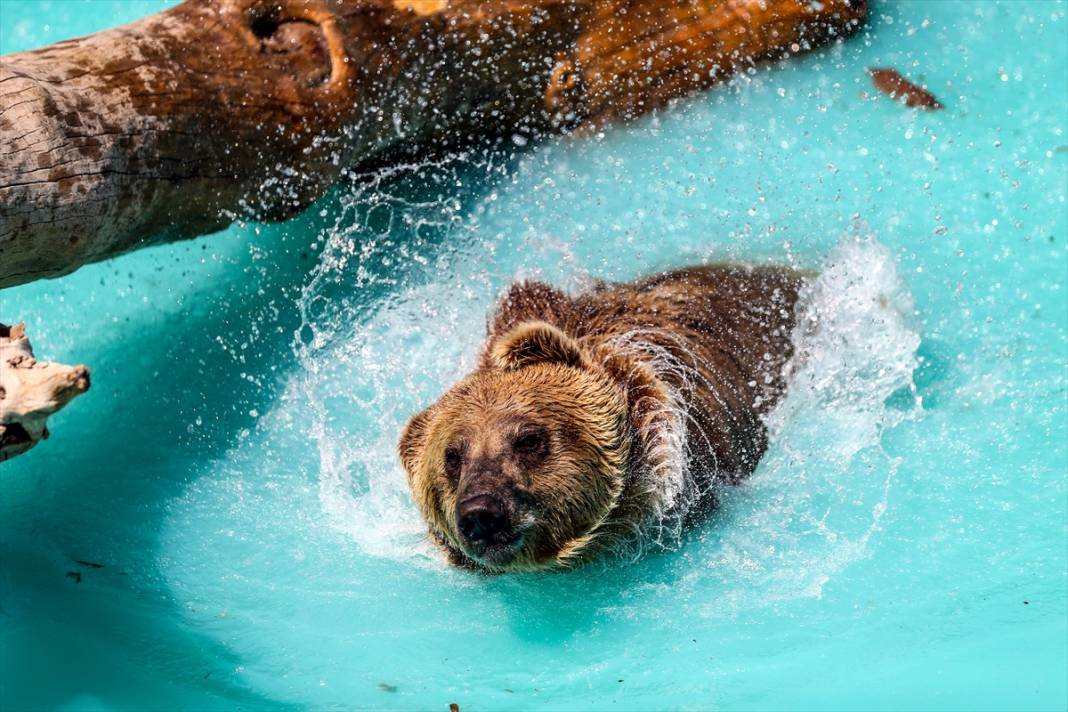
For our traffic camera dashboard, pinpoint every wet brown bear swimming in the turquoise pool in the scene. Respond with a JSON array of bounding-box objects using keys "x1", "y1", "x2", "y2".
[{"x1": 399, "y1": 265, "x2": 803, "y2": 571}]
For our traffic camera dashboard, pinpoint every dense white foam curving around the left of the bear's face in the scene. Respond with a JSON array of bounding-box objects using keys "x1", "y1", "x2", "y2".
[{"x1": 309, "y1": 284, "x2": 484, "y2": 559}]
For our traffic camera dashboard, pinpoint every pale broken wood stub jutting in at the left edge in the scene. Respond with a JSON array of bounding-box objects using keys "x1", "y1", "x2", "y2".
[{"x1": 0, "y1": 323, "x2": 89, "y2": 462}]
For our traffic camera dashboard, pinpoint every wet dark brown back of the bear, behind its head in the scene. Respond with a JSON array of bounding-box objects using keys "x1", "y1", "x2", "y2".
[{"x1": 486, "y1": 265, "x2": 804, "y2": 481}]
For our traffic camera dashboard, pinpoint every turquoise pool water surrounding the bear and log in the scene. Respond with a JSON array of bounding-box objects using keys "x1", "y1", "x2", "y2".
[{"x1": 0, "y1": 0, "x2": 1068, "y2": 712}]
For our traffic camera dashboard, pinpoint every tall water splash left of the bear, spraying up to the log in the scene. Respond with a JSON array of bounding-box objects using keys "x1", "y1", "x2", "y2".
[{"x1": 290, "y1": 155, "x2": 494, "y2": 561}]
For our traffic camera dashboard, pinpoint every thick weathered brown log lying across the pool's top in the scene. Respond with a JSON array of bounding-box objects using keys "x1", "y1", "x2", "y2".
[{"x1": 0, "y1": 0, "x2": 865, "y2": 287}]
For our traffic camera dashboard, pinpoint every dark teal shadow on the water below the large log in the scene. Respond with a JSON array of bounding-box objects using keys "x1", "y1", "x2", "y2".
[{"x1": 0, "y1": 137, "x2": 525, "y2": 707}]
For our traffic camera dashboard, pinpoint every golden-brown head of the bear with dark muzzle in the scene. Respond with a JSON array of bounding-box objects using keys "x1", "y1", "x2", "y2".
[{"x1": 401, "y1": 322, "x2": 629, "y2": 571}]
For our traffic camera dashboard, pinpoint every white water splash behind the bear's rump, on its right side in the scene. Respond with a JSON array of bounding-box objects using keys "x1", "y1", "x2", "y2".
[{"x1": 708, "y1": 237, "x2": 922, "y2": 613}]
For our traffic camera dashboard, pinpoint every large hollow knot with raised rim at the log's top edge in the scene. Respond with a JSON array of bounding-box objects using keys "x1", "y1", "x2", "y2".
[{"x1": 248, "y1": 2, "x2": 336, "y2": 89}]
